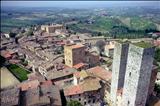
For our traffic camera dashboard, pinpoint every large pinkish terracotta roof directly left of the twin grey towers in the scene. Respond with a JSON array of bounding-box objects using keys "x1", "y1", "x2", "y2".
[{"x1": 88, "y1": 66, "x2": 112, "y2": 81}]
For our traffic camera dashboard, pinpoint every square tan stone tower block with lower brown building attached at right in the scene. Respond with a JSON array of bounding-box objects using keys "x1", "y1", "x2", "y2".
[{"x1": 64, "y1": 44, "x2": 99, "y2": 67}]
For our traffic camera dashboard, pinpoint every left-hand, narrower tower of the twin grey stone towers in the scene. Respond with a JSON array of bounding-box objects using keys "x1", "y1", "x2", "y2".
[{"x1": 111, "y1": 41, "x2": 129, "y2": 105}]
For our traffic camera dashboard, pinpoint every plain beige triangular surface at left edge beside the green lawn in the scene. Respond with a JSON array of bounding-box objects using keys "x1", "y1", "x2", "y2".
[{"x1": 1, "y1": 67, "x2": 20, "y2": 89}]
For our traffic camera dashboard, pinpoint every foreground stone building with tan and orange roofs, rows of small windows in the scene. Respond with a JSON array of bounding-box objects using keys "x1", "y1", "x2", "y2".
[{"x1": 64, "y1": 71, "x2": 104, "y2": 106}]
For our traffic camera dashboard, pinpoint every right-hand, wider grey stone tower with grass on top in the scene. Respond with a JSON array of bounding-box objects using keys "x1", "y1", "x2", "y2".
[{"x1": 122, "y1": 42, "x2": 154, "y2": 106}]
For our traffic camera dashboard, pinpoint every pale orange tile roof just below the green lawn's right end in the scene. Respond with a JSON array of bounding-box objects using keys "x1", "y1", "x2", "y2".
[{"x1": 18, "y1": 80, "x2": 39, "y2": 91}]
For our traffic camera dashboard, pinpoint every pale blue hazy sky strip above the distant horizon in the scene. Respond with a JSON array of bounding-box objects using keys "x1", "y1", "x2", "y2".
[{"x1": 1, "y1": 1, "x2": 160, "y2": 8}]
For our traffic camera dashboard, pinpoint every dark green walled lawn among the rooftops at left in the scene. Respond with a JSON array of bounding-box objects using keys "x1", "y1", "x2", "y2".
[{"x1": 7, "y1": 64, "x2": 30, "y2": 82}]
